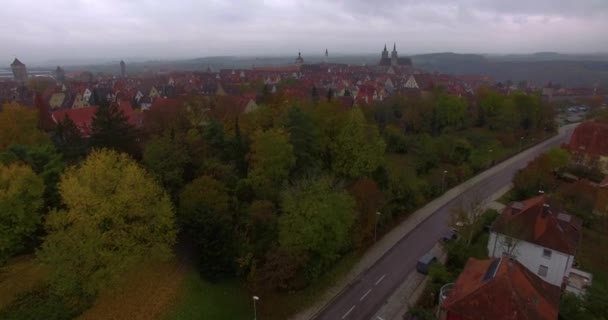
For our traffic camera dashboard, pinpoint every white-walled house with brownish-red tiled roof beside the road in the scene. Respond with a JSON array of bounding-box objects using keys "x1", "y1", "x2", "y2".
[{"x1": 488, "y1": 194, "x2": 582, "y2": 292}]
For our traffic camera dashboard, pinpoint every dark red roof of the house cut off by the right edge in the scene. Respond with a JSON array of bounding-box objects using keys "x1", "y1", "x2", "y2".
[{"x1": 568, "y1": 121, "x2": 608, "y2": 156}]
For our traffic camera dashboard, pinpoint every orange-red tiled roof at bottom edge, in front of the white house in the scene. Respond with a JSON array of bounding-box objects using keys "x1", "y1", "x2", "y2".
[{"x1": 443, "y1": 258, "x2": 560, "y2": 320}]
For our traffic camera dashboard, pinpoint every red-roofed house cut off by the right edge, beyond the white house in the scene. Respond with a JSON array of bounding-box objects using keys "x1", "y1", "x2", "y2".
[{"x1": 568, "y1": 121, "x2": 608, "y2": 174}]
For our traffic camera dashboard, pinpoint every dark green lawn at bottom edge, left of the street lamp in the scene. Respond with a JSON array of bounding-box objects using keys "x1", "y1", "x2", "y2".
[{"x1": 164, "y1": 271, "x2": 253, "y2": 320}]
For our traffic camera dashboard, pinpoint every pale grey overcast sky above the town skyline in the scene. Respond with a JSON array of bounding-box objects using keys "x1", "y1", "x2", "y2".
[{"x1": 0, "y1": 0, "x2": 608, "y2": 64}]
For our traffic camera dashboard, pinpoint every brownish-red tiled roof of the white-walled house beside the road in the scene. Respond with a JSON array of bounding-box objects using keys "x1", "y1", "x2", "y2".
[{"x1": 494, "y1": 195, "x2": 581, "y2": 255}]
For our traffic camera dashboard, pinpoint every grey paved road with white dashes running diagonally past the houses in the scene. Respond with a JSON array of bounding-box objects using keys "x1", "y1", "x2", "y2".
[{"x1": 315, "y1": 126, "x2": 574, "y2": 320}]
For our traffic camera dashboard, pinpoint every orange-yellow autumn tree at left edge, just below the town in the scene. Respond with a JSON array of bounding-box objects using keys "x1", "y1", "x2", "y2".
[{"x1": 0, "y1": 104, "x2": 49, "y2": 151}]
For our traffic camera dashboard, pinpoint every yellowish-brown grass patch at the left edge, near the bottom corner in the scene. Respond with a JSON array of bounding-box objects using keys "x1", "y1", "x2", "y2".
[{"x1": 0, "y1": 255, "x2": 45, "y2": 310}]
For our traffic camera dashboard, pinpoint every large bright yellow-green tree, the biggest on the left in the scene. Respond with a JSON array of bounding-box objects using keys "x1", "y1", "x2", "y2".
[{"x1": 38, "y1": 150, "x2": 176, "y2": 298}]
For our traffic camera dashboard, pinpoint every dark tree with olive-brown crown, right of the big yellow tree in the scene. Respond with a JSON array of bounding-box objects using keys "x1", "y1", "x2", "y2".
[{"x1": 179, "y1": 176, "x2": 235, "y2": 278}]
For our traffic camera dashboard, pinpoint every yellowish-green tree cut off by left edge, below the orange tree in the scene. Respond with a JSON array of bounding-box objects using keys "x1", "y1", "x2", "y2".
[{"x1": 0, "y1": 164, "x2": 44, "y2": 265}]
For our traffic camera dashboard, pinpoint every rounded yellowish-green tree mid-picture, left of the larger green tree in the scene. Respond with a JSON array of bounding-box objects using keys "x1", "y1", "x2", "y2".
[{"x1": 249, "y1": 129, "x2": 296, "y2": 197}]
